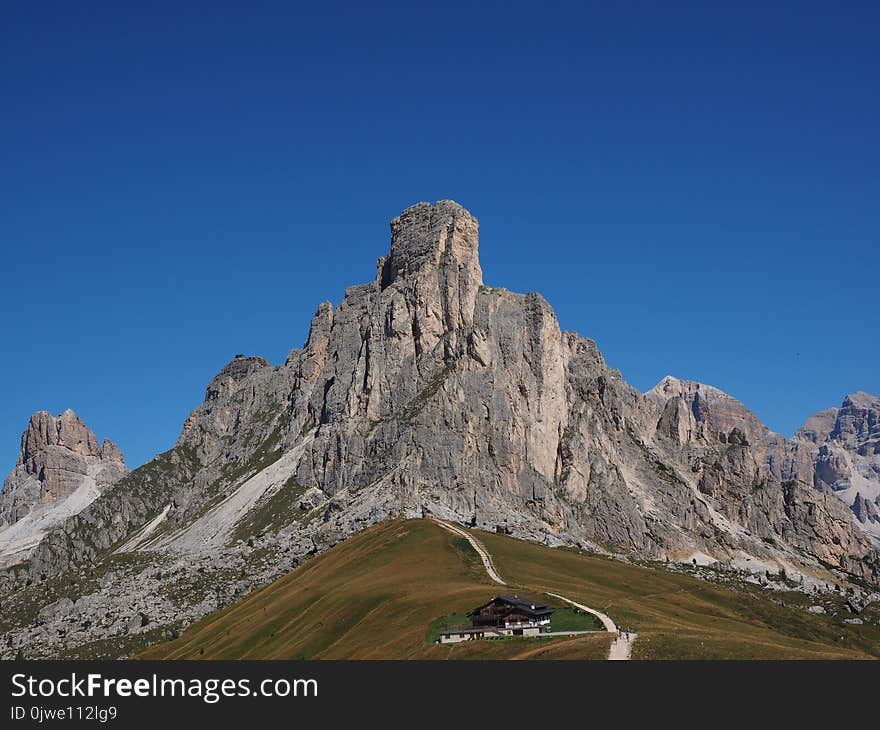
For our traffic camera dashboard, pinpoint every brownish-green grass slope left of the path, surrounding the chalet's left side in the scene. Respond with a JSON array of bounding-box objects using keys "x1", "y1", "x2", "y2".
[{"x1": 141, "y1": 520, "x2": 610, "y2": 659}]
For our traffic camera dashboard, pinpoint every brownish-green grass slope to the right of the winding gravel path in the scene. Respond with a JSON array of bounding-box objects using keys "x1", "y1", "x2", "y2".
[{"x1": 477, "y1": 532, "x2": 880, "y2": 659}]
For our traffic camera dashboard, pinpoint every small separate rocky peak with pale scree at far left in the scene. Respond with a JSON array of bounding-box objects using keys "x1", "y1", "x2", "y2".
[{"x1": 0, "y1": 410, "x2": 128, "y2": 565}]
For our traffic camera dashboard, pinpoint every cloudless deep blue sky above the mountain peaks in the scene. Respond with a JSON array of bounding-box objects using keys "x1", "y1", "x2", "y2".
[{"x1": 0, "y1": 1, "x2": 880, "y2": 466}]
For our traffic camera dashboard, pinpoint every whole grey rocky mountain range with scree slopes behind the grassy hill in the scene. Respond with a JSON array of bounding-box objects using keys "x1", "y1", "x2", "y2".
[{"x1": 0, "y1": 201, "x2": 880, "y2": 656}]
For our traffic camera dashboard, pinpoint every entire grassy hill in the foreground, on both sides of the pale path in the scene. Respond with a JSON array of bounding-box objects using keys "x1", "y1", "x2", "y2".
[{"x1": 141, "y1": 520, "x2": 880, "y2": 659}]
